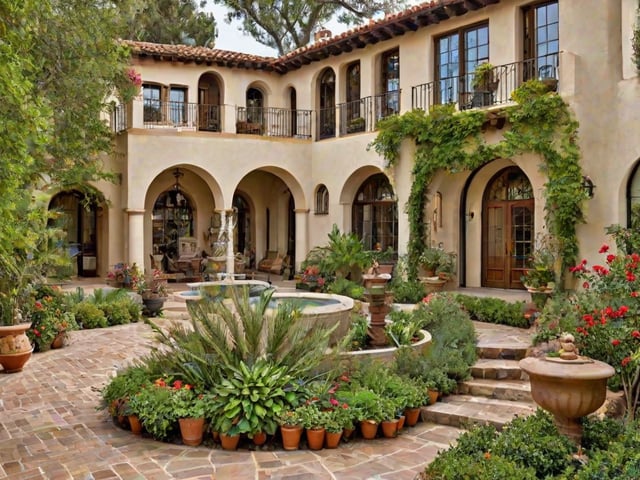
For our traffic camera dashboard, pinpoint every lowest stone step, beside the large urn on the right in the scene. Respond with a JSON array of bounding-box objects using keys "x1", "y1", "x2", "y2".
[{"x1": 421, "y1": 395, "x2": 536, "y2": 429}]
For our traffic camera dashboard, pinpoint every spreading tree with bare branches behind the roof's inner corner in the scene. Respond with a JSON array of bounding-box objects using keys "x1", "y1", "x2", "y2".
[{"x1": 214, "y1": 0, "x2": 406, "y2": 55}]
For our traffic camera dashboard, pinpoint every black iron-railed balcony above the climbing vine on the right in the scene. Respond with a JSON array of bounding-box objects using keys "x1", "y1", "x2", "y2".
[{"x1": 411, "y1": 54, "x2": 559, "y2": 112}]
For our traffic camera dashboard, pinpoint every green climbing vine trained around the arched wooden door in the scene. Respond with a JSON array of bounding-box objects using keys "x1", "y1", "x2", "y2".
[{"x1": 371, "y1": 80, "x2": 585, "y2": 277}]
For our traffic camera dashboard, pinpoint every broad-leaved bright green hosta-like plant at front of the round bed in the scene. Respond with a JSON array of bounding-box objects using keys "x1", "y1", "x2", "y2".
[{"x1": 211, "y1": 359, "x2": 298, "y2": 435}]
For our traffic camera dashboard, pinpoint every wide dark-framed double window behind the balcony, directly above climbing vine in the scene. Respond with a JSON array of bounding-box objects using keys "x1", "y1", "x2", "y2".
[{"x1": 435, "y1": 23, "x2": 489, "y2": 103}]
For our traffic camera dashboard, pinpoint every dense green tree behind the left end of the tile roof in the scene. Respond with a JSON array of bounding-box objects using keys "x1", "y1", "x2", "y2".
[{"x1": 120, "y1": 0, "x2": 216, "y2": 47}]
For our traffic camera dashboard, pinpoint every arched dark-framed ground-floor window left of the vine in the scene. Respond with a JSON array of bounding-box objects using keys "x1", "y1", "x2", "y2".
[{"x1": 352, "y1": 173, "x2": 398, "y2": 251}]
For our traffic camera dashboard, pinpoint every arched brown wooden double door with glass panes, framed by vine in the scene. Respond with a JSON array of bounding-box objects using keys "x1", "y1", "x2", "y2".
[{"x1": 482, "y1": 167, "x2": 535, "y2": 288}]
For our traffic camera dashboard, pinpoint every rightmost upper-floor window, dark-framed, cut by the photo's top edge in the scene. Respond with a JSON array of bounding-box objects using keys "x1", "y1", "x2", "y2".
[{"x1": 523, "y1": 1, "x2": 560, "y2": 80}]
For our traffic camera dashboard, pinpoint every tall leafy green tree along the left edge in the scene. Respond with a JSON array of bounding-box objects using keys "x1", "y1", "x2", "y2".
[{"x1": 0, "y1": 0, "x2": 129, "y2": 324}]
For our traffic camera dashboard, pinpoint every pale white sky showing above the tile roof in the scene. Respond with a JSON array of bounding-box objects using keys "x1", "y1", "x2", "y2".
[{"x1": 204, "y1": 0, "x2": 423, "y2": 57}]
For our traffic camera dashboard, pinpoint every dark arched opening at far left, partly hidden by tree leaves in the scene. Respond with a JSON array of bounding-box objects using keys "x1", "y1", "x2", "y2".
[{"x1": 49, "y1": 190, "x2": 98, "y2": 277}]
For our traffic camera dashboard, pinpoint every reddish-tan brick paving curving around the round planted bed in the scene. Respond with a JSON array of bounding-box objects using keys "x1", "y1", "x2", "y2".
[{"x1": 0, "y1": 280, "x2": 528, "y2": 480}]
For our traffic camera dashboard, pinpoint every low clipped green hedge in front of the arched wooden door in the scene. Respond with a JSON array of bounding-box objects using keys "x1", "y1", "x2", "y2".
[{"x1": 455, "y1": 294, "x2": 529, "y2": 328}]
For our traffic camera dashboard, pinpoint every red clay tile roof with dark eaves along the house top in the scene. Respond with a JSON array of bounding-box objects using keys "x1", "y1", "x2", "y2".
[{"x1": 125, "y1": 0, "x2": 500, "y2": 73}]
